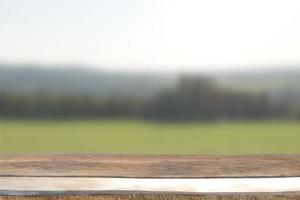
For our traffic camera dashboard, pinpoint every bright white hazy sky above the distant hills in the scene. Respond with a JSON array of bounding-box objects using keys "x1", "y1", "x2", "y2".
[{"x1": 0, "y1": 0, "x2": 300, "y2": 71}]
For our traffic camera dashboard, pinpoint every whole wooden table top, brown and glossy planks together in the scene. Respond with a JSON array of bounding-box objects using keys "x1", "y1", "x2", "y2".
[{"x1": 0, "y1": 154, "x2": 300, "y2": 200}]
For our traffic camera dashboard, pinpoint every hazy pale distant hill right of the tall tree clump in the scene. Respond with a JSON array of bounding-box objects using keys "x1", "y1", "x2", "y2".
[{"x1": 215, "y1": 66, "x2": 300, "y2": 106}]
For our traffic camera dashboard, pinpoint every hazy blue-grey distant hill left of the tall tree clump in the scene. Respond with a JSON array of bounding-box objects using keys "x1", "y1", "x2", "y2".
[{"x1": 0, "y1": 65, "x2": 175, "y2": 97}]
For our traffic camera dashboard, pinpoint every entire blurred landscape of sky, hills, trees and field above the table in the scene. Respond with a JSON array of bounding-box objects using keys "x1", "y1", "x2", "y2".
[{"x1": 0, "y1": 0, "x2": 300, "y2": 154}]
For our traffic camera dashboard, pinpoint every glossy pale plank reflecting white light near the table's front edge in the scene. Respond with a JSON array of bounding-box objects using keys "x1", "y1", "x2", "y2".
[{"x1": 0, "y1": 177, "x2": 300, "y2": 195}]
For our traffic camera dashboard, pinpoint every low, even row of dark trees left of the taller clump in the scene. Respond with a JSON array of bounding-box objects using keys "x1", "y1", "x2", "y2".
[{"x1": 0, "y1": 93, "x2": 139, "y2": 118}]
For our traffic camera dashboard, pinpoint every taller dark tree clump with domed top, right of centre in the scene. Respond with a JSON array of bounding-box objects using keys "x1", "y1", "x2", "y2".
[{"x1": 145, "y1": 77, "x2": 272, "y2": 120}]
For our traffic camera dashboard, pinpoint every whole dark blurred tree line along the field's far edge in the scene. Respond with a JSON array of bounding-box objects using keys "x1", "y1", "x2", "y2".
[{"x1": 0, "y1": 76, "x2": 300, "y2": 121}]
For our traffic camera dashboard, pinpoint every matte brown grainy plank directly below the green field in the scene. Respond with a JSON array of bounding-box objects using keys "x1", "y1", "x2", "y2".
[{"x1": 0, "y1": 154, "x2": 300, "y2": 178}]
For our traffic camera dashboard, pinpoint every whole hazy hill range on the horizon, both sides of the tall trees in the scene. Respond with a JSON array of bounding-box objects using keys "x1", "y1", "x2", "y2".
[{"x1": 0, "y1": 64, "x2": 300, "y2": 107}]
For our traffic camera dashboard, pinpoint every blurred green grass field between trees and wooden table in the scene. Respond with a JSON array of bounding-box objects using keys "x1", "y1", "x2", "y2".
[{"x1": 0, "y1": 120, "x2": 300, "y2": 154}]
